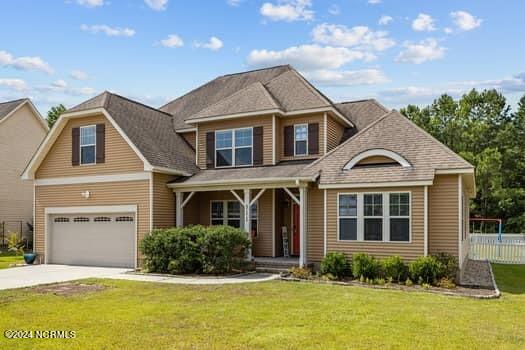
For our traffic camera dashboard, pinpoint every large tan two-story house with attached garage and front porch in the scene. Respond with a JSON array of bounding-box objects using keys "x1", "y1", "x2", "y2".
[{"x1": 23, "y1": 66, "x2": 475, "y2": 274}]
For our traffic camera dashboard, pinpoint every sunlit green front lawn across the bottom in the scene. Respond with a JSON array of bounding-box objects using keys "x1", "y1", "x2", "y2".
[{"x1": 0, "y1": 265, "x2": 525, "y2": 350}]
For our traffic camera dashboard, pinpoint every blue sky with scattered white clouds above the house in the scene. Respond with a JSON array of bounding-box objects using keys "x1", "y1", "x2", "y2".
[{"x1": 0, "y1": 0, "x2": 525, "y2": 113}]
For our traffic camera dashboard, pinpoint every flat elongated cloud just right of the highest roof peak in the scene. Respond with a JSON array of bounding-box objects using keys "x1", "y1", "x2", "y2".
[{"x1": 304, "y1": 69, "x2": 389, "y2": 86}]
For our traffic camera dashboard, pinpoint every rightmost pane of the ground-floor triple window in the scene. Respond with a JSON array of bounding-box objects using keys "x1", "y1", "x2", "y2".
[{"x1": 390, "y1": 193, "x2": 410, "y2": 242}]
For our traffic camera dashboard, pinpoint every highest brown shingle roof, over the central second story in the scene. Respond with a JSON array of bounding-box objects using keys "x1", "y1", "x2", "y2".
[{"x1": 160, "y1": 65, "x2": 351, "y2": 130}]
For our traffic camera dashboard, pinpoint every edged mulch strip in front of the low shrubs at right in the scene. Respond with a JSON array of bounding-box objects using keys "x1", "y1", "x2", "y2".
[{"x1": 281, "y1": 276, "x2": 500, "y2": 299}]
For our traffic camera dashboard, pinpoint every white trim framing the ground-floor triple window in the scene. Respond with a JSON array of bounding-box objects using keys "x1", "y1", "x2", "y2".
[{"x1": 336, "y1": 191, "x2": 412, "y2": 244}]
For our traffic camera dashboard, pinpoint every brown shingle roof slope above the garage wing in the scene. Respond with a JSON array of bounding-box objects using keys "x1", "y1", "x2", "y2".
[{"x1": 68, "y1": 91, "x2": 198, "y2": 174}]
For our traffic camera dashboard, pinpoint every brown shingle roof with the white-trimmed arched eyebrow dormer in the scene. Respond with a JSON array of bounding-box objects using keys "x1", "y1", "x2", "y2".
[{"x1": 305, "y1": 111, "x2": 473, "y2": 185}]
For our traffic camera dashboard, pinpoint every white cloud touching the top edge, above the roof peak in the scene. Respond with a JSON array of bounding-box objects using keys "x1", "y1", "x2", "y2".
[{"x1": 260, "y1": 0, "x2": 314, "y2": 22}]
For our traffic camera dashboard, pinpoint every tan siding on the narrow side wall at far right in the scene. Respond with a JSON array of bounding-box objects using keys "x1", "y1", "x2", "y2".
[{"x1": 428, "y1": 175, "x2": 459, "y2": 256}]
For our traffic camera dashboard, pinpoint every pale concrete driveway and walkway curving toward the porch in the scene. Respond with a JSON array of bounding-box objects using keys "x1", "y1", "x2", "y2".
[{"x1": 0, "y1": 265, "x2": 279, "y2": 290}]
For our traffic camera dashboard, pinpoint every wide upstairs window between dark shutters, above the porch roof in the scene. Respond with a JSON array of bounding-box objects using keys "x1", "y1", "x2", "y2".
[{"x1": 215, "y1": 128, "x2": 253, "y2": 168}]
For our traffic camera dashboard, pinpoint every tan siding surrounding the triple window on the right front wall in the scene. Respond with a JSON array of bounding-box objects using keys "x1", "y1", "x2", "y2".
[{"x1": 326, "y1": 186, "x2": 424, "y2": 261}]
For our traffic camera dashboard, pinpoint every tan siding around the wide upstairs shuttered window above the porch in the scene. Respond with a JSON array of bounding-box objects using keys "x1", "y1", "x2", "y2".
[{"x1": 197, "y1": 115, "x2": 273, "y2": 169}]
